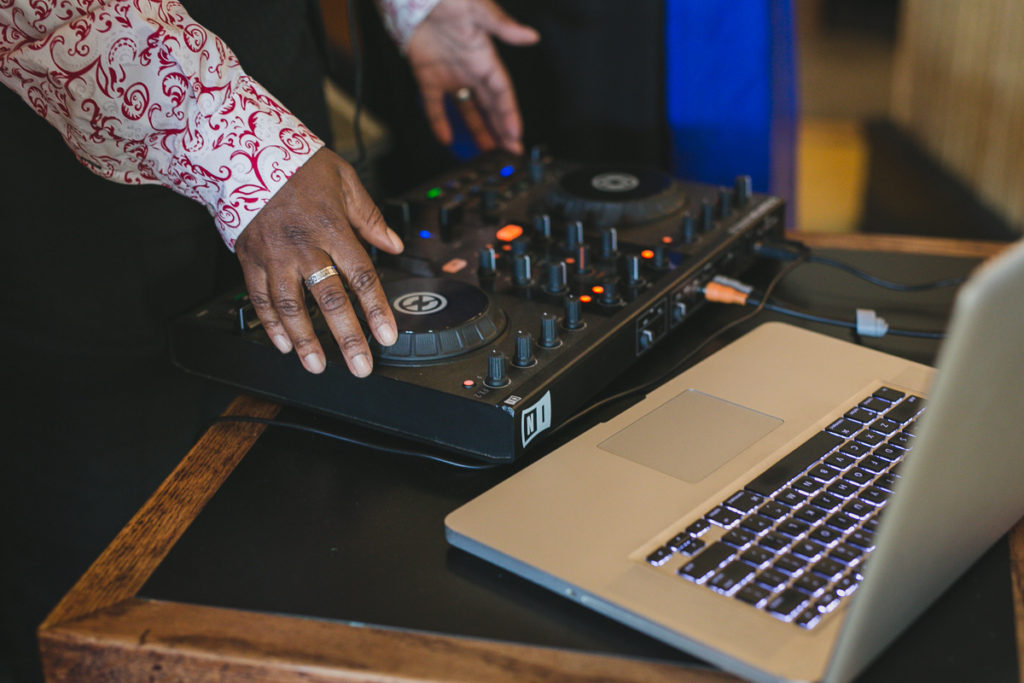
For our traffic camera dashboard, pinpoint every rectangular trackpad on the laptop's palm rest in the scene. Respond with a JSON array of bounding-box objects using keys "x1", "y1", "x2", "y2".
[{"x1": 598, "y1": 389, "x2": 782, "y2": 483}]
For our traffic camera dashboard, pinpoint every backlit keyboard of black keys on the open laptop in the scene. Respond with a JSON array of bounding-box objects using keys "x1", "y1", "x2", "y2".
[{"x1": 646, "y1": 387, "x2": 925, "y2": 629}]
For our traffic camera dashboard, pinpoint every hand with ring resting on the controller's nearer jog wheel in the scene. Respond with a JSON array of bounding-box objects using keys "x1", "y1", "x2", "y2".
[{"x1": 236, "y1": 147, "x2": 402, "y2": 377}]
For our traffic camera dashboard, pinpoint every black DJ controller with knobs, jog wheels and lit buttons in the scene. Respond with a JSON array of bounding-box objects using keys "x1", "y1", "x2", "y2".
[{"x1": 171, "y1": 147, "x2": 784, "y2": 462}]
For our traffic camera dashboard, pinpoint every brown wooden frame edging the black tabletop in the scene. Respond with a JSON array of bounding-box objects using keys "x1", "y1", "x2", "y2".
[{"x1": 39, "y1": 234, "x2": 1024, "y2": 681}]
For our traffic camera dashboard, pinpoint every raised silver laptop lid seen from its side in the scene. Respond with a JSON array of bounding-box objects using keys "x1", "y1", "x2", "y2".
[{"x1": 826, "y1": 237, "x2": 1024, "y2": 681}]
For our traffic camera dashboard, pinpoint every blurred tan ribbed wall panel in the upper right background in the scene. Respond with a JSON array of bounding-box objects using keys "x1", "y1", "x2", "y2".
[{"x1": 892, "y1": 0, "x2": 1024, "y2": 231}]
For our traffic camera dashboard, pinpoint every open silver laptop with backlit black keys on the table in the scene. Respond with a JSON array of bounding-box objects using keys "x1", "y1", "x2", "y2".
[{"x1": 445, "y1": 237, "x2": 1024, "y2": 681}]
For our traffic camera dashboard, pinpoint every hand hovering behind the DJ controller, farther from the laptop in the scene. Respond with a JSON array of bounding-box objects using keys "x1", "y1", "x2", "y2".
[{"x1": 407, "y1": 0, "x2": 540, "y2": 154}]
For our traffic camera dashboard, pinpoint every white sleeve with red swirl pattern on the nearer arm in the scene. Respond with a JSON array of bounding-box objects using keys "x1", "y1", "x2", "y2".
[{"x1": 0, "y1": 0, "x2": 324, "y2": 250}]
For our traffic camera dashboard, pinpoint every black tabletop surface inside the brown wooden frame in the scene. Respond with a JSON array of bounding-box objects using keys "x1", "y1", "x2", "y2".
[{"x1": 140, "y1": 251, "x2": 1019, "y2": 681}]
